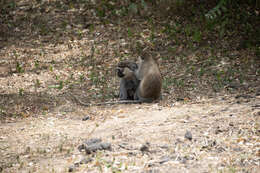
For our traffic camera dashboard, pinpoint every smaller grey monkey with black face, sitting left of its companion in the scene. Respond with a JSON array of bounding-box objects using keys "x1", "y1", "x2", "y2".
[{"x1": 116, "y1": 62, "x2": 139, "y2": 100}]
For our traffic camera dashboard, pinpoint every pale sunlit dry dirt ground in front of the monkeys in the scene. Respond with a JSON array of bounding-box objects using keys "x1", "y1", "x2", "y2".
[{"x1": 0, "y1": 96, "x2": 260, "y2": 173}]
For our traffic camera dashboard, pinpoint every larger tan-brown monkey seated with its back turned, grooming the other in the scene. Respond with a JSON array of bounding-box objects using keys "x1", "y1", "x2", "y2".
[{"x1": 118, "y1": 53, "x2": 162, "y2": 102}]
